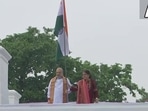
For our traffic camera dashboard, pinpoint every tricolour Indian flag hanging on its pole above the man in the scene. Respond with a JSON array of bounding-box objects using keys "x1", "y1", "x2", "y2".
[{"x1": 54, "y1": 0, "x2": 70, "y2": 60}]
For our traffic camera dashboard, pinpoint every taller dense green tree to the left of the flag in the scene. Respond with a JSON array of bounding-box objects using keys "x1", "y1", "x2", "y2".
[{"x1": 2, "y1": 27, "x2": 56, "y2": 102}]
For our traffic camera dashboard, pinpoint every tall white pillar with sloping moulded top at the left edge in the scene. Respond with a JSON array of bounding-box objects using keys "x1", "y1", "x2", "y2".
[{"x1": 0, "y1": 46, "x2": 11, "y2": 104}]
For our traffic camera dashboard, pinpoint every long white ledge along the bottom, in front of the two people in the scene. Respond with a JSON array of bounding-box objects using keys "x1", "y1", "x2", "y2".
[{"x1": 0, "y1": 103, "x2": 148, "y2": 111}]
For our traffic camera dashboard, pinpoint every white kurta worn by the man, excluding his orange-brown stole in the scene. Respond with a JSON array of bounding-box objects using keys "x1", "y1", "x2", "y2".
[{"x1": 47, "y1": 78, "x2": 72, "y2": 103}]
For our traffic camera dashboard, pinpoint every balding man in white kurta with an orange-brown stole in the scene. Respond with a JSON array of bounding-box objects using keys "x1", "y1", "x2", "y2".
[{"x1": 47, "y1": 68, "x2": 72, "y2": 104}]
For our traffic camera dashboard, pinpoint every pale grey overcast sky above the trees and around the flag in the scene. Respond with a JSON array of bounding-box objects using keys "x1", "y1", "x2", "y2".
[{"x1": 0, "y1": 0, "x2": 148, "y2": 101}]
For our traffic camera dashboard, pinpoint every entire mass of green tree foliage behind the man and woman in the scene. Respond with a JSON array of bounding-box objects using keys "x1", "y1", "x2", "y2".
[{"x1": 0, "y1": 27, "x2": 146, "y2": 102}]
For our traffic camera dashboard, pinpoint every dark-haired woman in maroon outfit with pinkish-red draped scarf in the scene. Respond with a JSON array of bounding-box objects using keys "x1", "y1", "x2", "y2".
[{"x1": 71, "y1": 70, "x2": 98, "y2": 104}]
